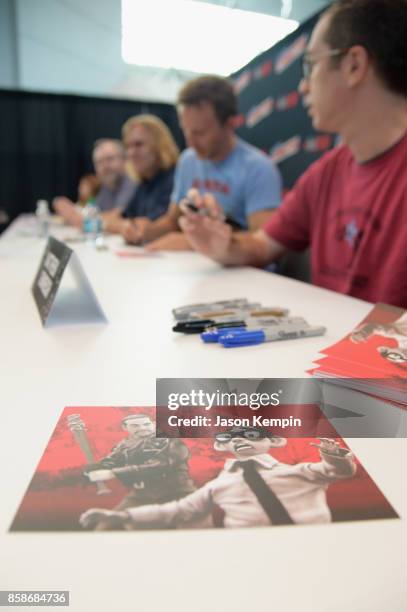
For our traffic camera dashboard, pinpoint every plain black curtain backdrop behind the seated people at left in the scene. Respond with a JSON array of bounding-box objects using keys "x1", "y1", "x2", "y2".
[{"x1": 0, "y1": 90, "x2": 184, "y2": 225}]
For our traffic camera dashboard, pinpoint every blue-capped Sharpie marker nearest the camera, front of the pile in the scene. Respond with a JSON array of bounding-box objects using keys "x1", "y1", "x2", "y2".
[{"x1": 218, "y1": 326, "x2": 326, "y2": 348}]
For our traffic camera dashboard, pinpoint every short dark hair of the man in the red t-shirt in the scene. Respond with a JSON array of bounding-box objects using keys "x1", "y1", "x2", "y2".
[{"x1": 324, "y1": 0, "x2": 407, "y2": 97}]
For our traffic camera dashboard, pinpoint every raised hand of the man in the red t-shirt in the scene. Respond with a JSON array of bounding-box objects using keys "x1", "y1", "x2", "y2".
[{"x1": 179, "y1": 189, "x2": 232, "y2": 262}]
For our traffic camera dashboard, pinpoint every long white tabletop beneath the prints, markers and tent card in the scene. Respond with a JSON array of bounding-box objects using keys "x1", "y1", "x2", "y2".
[{"x1": 0, "y1": 216, "x2": 407, "y2": 612}]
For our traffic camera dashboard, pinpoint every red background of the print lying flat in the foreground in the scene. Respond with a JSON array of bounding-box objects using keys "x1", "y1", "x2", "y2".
[{"x1": 10, "y1": 407, "x2": 397, "y2": 531}]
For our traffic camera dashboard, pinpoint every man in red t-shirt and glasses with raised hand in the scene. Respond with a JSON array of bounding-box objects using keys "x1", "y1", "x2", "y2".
[{"x1": 180, "y1": 0, "x2": 407, "y2": 308}]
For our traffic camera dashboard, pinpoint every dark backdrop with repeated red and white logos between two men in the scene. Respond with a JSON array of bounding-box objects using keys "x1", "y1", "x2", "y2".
[{"x1": 232, "y1": 9, "x2": 335, "y2": 189}]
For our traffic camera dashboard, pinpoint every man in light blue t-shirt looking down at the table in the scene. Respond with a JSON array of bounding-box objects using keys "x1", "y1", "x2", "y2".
[{"x1": 124, "y1": 76, "x2": 281, "y2": 250}]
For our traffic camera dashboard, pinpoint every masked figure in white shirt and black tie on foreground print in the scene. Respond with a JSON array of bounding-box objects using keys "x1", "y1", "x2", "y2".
[{"x1": 80, "y1": 427, "x2": 356, "y2": 529}]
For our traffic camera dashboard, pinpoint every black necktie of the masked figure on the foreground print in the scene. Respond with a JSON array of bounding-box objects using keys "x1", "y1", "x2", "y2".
[{"x1": 236, "y1": 459, "x2": 294, "y2": 525}]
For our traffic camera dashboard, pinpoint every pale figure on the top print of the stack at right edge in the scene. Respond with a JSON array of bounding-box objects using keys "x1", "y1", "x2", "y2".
[{"x1": 350, "y1": 312, "x2": 407, "y2": 365}]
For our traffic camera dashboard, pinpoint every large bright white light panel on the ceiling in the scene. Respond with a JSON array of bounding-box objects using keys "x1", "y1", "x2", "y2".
[{"x1": 122, "y1": 0, "x2": 298, "y2": 75}]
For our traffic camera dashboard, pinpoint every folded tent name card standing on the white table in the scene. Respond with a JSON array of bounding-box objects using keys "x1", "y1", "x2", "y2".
[{"x1": 32, "y1": 237, "x2": 107, "y2": 327}]
